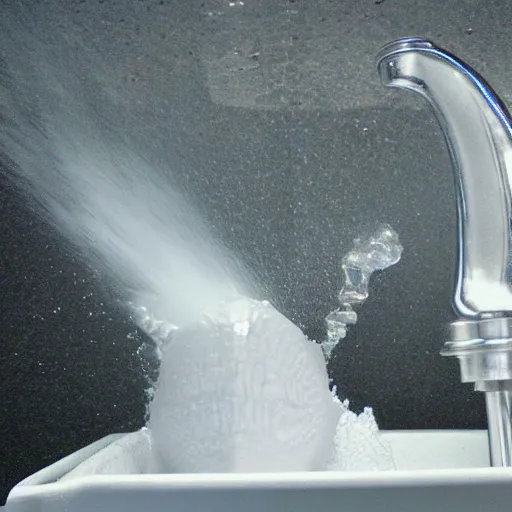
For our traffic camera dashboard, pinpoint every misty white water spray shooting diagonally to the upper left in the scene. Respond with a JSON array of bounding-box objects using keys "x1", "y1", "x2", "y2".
[{"x1": 0, "y1": 9, "x2": 256, "y2": 339}]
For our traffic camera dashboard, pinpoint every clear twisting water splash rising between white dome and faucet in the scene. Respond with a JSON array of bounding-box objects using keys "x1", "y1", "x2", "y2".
[{"x1": 322, "y1": 224, "x2": 403, "y2": 359}]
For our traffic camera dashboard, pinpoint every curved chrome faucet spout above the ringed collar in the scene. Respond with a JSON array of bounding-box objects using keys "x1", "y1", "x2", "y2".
[{"x1": 377, "y1": 38, "x2": 512, "y2": 318}]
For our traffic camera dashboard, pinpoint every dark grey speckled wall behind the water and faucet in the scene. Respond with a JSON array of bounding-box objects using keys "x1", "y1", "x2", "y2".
[{"x1": 4, "y1": 0, "x2": 512, "y2": 502}]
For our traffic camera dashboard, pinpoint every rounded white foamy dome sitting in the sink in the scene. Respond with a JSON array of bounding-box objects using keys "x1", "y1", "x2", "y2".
[{"x1": 149, "y1": 298, "x2": 340, "y2": 472}]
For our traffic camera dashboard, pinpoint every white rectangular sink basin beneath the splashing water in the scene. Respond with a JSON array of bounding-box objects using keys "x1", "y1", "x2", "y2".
[{"x1": 6, "y1": 430, "x2": 512, "y2": 512}]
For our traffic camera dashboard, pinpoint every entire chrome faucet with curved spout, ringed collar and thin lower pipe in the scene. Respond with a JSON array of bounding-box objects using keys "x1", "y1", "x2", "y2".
[{"x1": 377, "y1": 38, "x2": 512, "y2": 467}]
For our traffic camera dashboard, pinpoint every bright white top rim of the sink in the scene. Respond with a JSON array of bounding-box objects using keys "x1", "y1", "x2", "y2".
[{"x1": 9, "y1": 430, "x2": 500, "y2": 496}]
